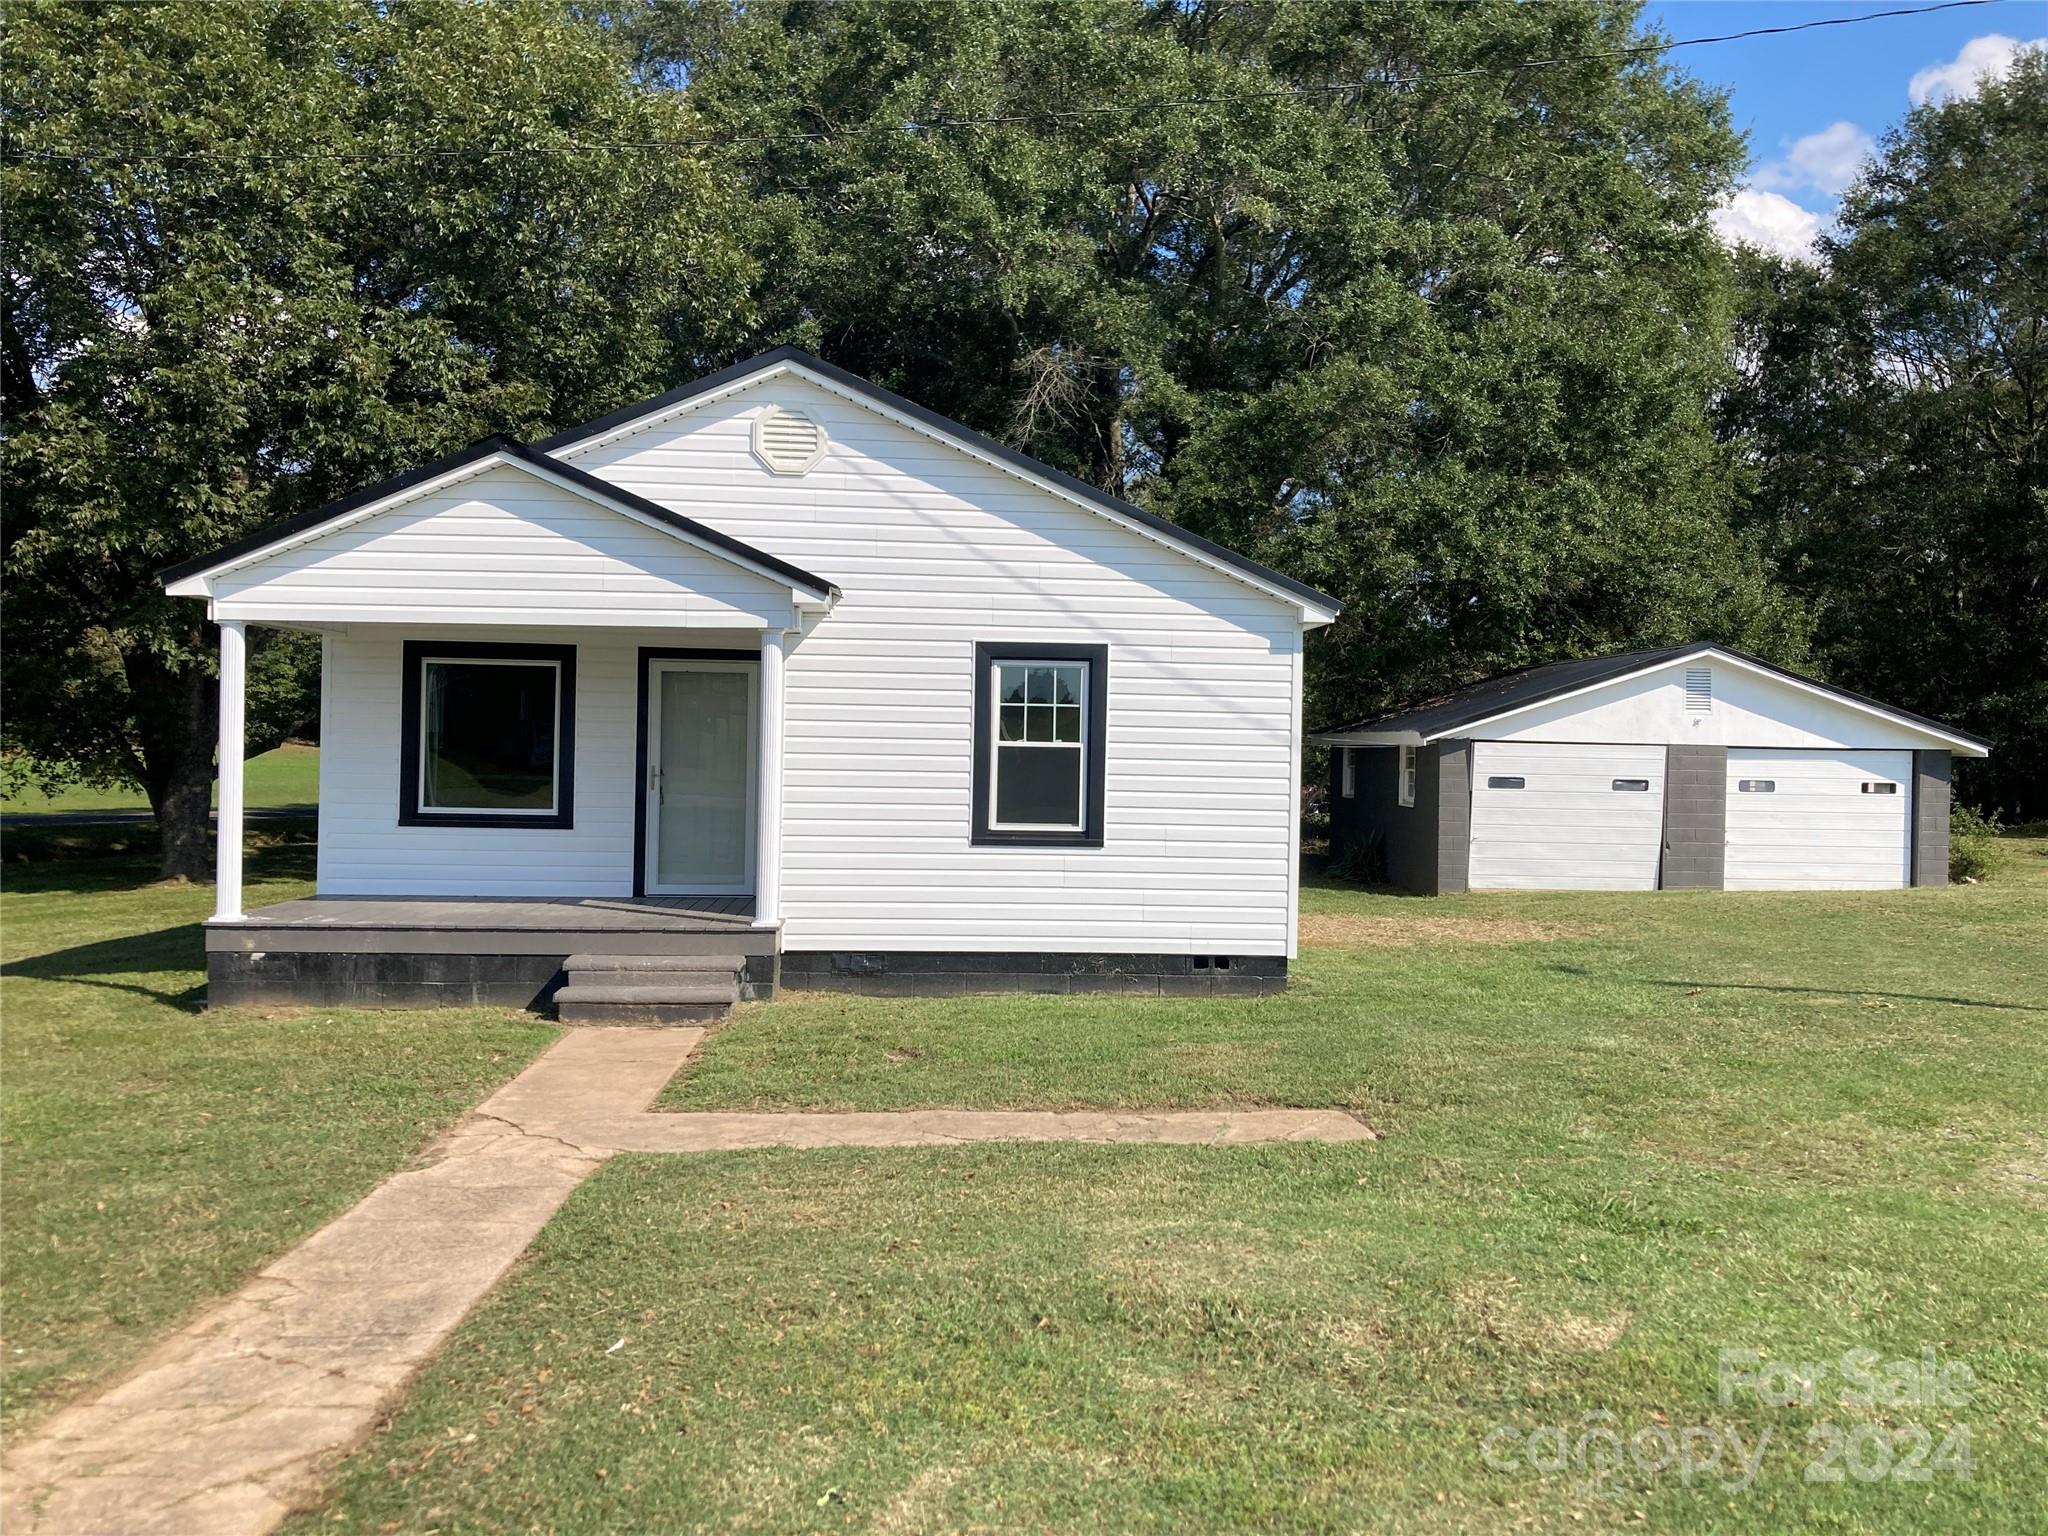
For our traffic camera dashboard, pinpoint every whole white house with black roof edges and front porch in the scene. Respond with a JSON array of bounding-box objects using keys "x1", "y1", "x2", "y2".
[{"x1": 164, "y1": 348, "x2": 1337, "y2": 1016}]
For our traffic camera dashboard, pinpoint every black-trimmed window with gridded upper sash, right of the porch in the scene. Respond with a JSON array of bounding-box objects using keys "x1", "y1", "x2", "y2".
[{"x1": 973, "y1": 643, "x2": 1110, "y2": 848}]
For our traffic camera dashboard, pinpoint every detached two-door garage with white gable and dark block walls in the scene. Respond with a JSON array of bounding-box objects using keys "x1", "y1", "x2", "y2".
[{"x1": 1313, "y1": 645, "x2": 1987, "y2": 895}]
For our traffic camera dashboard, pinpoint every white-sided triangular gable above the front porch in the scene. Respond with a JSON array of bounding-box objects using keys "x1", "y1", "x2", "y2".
[{"x1": 213, "y1": 465, "x2": 791, "y2": 629}]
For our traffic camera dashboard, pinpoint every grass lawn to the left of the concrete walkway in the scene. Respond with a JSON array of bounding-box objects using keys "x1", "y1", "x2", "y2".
[{"x1": 0, "y1": 829, "x2": 553, "y2": 1434}]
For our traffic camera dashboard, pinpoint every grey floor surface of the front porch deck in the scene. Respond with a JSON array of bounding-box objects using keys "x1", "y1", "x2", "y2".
[{"x1": 244, "y1": 895, "x2": 754, "y2": 934}]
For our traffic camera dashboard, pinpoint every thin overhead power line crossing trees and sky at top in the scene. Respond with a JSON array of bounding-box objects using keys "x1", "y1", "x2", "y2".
[{"x1": 0, "y1": 0, "x2": 1999, "y2": 164}]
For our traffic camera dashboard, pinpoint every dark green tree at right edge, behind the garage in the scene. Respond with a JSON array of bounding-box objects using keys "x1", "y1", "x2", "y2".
[{"x1": 1724, "y1": 51, "x2": 2048, "y2": 817}]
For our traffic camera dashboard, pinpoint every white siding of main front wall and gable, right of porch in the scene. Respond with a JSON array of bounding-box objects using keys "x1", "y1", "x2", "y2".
[{"x1": 563, "y1": 379, "x2": 1300, "y2": 954}]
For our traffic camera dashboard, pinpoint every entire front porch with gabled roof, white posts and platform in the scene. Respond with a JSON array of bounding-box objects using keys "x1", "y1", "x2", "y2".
[{"x1": 166, "y1": 438, "x2": 838, "y2": 1008}]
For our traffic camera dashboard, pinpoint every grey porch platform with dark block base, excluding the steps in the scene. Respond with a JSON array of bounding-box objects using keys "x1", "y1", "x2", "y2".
[{"x1": 207, "y1": 895, "x2": 780, "y2": 1008}]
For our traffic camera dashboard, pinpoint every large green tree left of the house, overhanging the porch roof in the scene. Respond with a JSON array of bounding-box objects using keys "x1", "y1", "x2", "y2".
[{"x1": 0, "y1": 0, "x2": 752, "y2": 877}]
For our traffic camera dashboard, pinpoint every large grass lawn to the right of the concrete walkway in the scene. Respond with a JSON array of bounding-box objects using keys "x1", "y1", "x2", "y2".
[{"x1": 295, "y1": 840, "x2": 2048, "y2": 1536}]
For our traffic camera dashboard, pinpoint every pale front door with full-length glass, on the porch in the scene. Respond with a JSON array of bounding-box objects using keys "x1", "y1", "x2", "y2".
[{"x1": 643, "y1": 659, "x2": 760, "y2": 895}]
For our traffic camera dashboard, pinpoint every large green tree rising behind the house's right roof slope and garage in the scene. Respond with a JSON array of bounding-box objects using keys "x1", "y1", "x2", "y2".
[{"x1": 606, "y1": 0, "x2": 1802, "y2": 729}]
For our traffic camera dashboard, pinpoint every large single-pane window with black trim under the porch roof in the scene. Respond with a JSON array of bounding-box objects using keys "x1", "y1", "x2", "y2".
[{"x1": 397, "y1": 641, "x2": 575, "y2": 827}]
